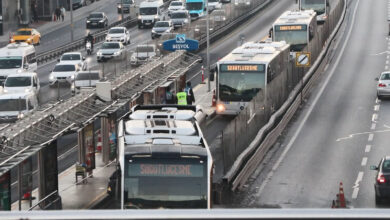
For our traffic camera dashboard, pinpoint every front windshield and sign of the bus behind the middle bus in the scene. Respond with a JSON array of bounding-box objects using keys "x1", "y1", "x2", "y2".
[{"x1": 274, "y1": 25, "x2": 309, "y2": 51}]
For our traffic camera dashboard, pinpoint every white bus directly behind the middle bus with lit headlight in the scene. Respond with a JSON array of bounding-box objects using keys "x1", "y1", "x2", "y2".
[{"x1": 271, "y1": 10, "x2": 317, "y2": 54}]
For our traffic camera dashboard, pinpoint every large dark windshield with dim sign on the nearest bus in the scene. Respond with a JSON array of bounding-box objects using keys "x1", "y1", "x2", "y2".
[{"x1": 124, "y1": 158, "x2": 208, "y2": 209}]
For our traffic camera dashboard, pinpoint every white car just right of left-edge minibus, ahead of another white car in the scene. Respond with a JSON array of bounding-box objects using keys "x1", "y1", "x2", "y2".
[{"x1": 49, "y1": 63, "x2": 80, "y2": 86}]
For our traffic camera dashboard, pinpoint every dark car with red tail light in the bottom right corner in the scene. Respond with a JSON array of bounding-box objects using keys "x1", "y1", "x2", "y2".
[{"x1": 370, "y1": 156, "x2": 390, "y2": 204}]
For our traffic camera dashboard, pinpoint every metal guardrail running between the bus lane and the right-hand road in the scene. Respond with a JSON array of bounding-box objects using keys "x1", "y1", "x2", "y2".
[{"x1": 223, "y1": 0, "x2": 347, "y2": 191}]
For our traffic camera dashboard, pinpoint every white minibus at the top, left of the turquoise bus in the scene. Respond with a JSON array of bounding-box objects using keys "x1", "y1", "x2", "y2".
[{"x1": 138, "y1": 0, "x2": 165, "y2": 28}]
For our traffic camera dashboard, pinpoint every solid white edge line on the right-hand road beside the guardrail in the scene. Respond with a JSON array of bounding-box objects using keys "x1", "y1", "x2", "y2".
[{"x1": 256, "y1": 0, "x2": 360, "y2": 197}]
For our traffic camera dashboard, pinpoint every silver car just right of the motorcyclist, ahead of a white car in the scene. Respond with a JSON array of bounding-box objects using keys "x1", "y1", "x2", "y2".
[{"x1": 96, "y1": 42, "x2": 125, "y2": 62}]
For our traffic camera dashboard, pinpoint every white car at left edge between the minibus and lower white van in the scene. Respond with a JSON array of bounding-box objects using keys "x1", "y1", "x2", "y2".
[{"x1": 3, "y1": 72, "x2": 41, "y2": 96}]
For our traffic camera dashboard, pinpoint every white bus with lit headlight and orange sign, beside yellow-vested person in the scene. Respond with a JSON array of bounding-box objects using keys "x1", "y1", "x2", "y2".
[{"x1": 216, "y1": 42, "x2": 290, "y2": 115}]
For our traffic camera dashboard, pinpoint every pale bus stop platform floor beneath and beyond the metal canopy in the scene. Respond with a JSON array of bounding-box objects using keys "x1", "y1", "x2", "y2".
[{"x1": 11, "y1": 78, "x2": 215, "y2": 211}]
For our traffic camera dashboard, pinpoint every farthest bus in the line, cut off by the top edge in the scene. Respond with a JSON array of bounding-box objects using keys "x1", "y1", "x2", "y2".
[{"x1": 299, "y1": 0, "x2": 329, "y2": 23}]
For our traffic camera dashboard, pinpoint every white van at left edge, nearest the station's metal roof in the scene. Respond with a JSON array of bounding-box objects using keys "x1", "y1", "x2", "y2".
[{"x1": 0, "y1": 92, "x2": 38, "y2": 123}]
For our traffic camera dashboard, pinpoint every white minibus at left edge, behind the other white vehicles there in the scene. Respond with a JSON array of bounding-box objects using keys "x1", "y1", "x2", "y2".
[{"x1": 0, "y1": 43, "x2": 37, "y2": 83}]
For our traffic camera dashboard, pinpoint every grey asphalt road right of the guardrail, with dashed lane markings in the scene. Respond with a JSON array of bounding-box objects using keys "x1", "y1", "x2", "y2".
[{"x1": 228, "y1": 0, "x2": 390, "y2": 208}]
